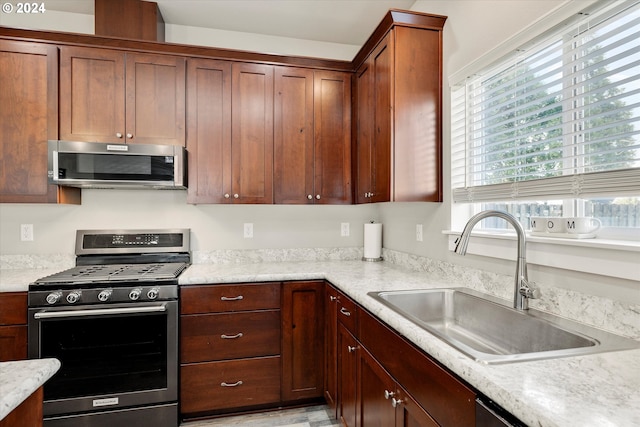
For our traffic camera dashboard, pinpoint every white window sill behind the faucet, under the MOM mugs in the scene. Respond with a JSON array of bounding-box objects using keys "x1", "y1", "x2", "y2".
[{"x1": 443, "y1": 230, "x2": 640, "y2": 281}]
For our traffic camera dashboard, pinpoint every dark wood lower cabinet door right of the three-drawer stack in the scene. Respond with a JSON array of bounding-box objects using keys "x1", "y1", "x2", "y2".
[{"x1": 282, "y1": 281, "x2": 324, "y2": 401}]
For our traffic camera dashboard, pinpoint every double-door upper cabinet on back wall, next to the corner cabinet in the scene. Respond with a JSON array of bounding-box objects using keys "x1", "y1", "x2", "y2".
[{"x1": 274, "y1": 67, "x2": 352, "y2": 204}]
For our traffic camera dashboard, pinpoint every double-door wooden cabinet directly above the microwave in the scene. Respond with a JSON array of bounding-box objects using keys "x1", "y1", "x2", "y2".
[{"x1": 60, "y1": 46, "x2": 186, "y2": 145}]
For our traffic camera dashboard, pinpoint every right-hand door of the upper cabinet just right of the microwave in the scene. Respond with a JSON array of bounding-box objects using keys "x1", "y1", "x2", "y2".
[{"x1": 231, "y1": 63, "x2": 273, "y2": 203}]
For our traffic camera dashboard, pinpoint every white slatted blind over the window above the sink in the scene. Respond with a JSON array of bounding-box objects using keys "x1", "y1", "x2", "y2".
[{"x1": 451, "y1": 0, "x2": 640, "y2": 202}]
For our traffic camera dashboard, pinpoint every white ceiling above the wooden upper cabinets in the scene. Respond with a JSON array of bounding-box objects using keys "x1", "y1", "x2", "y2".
[{"x1": 46, "y1": 0, "x2": 416, "y2": 46}]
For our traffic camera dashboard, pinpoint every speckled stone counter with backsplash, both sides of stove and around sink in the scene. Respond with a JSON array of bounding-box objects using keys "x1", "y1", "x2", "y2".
[{"x1": 0, "y1": 254, "x2": 640, "y2": 427}]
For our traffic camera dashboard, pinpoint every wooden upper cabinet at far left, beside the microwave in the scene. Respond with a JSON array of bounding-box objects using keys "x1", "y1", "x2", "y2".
[{"x1": 0, "y1": 40, "x2": 80, "y2": 203}]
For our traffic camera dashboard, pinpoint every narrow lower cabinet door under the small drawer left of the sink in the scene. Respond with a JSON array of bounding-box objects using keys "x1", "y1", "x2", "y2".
[{"x1": 338, "y1": 323, "x2": 359, "y2": 427}]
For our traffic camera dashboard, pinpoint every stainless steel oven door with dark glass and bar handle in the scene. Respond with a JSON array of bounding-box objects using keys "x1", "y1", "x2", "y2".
[{"x1": 29, "y1": 301, "x2": 178, "y2": 417}]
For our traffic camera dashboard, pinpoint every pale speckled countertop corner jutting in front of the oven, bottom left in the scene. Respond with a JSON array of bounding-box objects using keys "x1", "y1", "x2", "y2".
[{"x1": 0, "y1": 359, "x2": 60, "y2": 420}]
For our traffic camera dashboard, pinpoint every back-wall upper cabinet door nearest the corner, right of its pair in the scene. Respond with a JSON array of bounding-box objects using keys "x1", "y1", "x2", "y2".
[{"x1": 313, "y1": 71, "x2": 353, "y2": 204}]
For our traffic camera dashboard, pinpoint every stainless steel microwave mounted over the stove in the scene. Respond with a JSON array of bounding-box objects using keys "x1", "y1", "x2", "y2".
[{"x1": 48, "y1": 140, "x2": 187, "y2": 189}]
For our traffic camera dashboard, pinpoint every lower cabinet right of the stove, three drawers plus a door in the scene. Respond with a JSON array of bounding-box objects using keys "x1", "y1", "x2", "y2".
[{"x1": 180, "y1": 281, "x2": 325, "y2": 418}]
